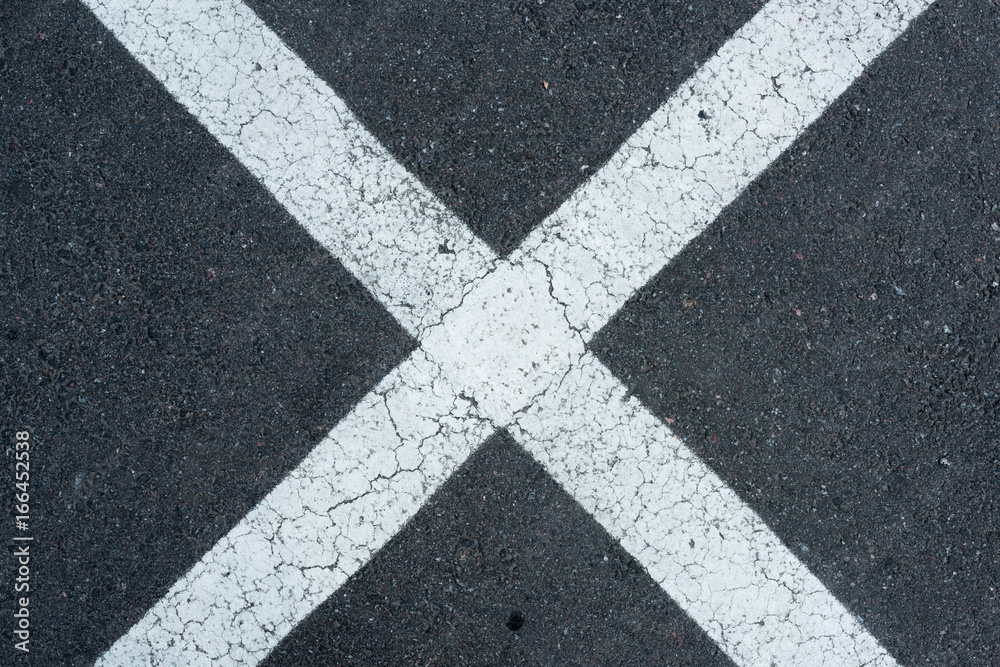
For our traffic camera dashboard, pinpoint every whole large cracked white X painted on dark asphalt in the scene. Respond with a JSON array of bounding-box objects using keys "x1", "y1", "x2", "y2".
[{"x1": 89, "y1": 0, "x2": 927, "y2": 665}]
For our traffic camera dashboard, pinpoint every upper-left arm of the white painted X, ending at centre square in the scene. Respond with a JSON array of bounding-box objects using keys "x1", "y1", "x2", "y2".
[{"x1": 84, "y1": 0, "x2": 495, "y2": 335}]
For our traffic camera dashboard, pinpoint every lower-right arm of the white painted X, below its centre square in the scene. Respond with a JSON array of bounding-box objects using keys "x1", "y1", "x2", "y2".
[{"x1": 511, "y1": 354, "x2": 895, "y2": 667}]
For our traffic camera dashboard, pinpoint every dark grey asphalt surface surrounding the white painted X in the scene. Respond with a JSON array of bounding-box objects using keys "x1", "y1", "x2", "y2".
[{"x1": 0, "y1": 0, "x2": 1000, "y2": 666}]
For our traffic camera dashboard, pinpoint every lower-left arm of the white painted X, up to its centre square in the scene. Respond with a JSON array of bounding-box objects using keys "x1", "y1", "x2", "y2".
[{"x1": 97, "y1": 351, "x2": 492, "y2": 667}]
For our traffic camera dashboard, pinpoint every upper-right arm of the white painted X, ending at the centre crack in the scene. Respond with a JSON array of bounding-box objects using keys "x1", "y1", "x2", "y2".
[{"x1": 511, "y1": 0, "x2": 930, "y2": 340}]
